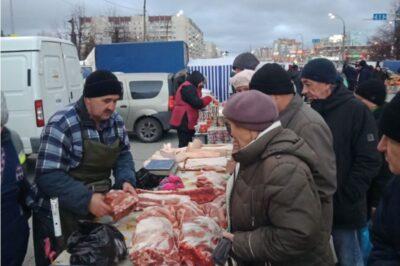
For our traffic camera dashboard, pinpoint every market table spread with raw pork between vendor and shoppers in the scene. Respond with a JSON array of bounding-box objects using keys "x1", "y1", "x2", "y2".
[{"x1": 53, "y1": 140, "x2": 232, "y2": 265}]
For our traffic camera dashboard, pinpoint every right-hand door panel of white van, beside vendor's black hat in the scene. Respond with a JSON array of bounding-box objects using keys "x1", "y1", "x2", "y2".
[{"x1": 61, "y1": 43, "x2": 83, "y2": 103}]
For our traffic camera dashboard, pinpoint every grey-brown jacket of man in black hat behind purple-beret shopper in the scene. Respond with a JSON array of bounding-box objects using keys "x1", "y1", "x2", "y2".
[{"x1": 279, "y1": 95, "x2": 337, "y2": 239}]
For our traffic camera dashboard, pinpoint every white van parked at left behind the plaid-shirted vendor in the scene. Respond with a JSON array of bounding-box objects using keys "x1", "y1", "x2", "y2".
[{"x1": 0, "y1": 36, "x2": 83, "y2": 154}]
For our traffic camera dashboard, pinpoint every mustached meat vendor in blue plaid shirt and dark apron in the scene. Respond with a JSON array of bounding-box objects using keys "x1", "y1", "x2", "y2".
[{"x1": 33, "y1": 70, "x2": 136, "y2": 265}]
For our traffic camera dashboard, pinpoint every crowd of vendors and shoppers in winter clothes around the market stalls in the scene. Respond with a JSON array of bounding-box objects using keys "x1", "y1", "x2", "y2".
[{"x1": 1, "y1": 53, "x2": 400, "y2": 266}]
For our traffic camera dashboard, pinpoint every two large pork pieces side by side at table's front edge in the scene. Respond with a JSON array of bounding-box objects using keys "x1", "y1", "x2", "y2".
[{"x1": 130, "y1": 202, "x2": 222, "y2": 266}]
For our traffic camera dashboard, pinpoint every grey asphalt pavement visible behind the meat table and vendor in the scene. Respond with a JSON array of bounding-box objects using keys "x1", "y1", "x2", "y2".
[{"x1": 23, "y1": 130, "x2": 178, "y2": 266}]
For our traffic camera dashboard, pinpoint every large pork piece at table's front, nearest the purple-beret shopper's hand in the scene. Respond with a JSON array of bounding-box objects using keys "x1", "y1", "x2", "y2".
[{"x1": 179, "y1": 216, "x2": 222, "y2": 266}]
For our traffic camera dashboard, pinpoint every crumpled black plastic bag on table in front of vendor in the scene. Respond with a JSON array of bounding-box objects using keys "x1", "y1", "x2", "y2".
[{"x1": 67, "y1": 221, "x2": 127, "y2": 266}]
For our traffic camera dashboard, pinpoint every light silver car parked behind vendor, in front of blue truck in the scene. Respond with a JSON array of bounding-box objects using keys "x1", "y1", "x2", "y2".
[{"x1": 114, "y1": 72, "x2": 177, "y2": 142}]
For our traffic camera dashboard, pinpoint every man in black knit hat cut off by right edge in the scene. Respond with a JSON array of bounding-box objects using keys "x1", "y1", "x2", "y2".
[{"x1": 368, "y1": 93, "x2": 400, "y2": 266}]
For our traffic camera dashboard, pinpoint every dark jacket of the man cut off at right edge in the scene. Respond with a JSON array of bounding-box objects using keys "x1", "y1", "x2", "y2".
[{"x1": 368, "y1": 176, "x2": 400, "y2": 266}]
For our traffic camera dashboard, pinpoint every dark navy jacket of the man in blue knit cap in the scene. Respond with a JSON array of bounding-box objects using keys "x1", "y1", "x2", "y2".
[{"x1": 311, "y1": 84, "x2": 381, "y2": 229}]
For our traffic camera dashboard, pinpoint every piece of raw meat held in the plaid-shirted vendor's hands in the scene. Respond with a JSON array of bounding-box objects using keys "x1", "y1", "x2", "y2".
[{"x1": 104, "y1": 190, "x2": 139, "y2": 221}]
